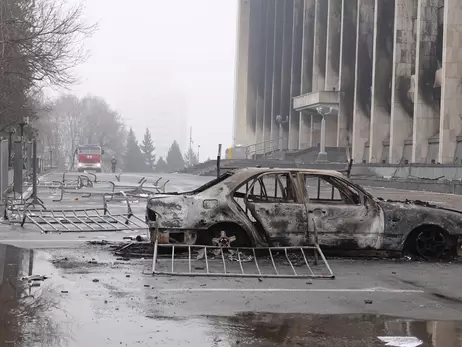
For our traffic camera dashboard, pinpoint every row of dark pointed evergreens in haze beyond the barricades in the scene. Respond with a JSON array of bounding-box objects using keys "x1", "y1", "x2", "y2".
[{"x1": 123, "y1": 129, "x2": 199, "y2": 172}]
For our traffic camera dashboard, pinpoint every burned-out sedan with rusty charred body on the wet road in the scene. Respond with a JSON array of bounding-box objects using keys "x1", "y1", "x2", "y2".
[{"x1": 146, "y1": 168, "x2": 462, "y2": 258}]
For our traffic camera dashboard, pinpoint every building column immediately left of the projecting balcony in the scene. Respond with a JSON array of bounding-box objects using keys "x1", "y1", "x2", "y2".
[{"x1": 280, "y1": 0, "x2": 294, "y2": 150}]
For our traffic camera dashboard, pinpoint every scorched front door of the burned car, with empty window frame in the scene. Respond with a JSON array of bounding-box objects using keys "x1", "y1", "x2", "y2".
[{"x1": 303, "y1": 174, "x2": 384, "y2": 250}]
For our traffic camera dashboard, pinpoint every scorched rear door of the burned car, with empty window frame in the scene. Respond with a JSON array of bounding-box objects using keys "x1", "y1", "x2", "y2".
[{"x1": 245, "y1": 171, "x2": 308, "y2": 246}]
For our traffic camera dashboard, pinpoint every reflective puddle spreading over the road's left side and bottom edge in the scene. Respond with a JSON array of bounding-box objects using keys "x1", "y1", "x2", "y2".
[{"x1": 0, "y1": 245, "x2": 462, "y2": 347}]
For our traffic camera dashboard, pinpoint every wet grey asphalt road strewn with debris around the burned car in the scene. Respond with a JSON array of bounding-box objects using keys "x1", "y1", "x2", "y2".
[{"x1": 0, "y1": 174, "x2": 462, "y2": 347}]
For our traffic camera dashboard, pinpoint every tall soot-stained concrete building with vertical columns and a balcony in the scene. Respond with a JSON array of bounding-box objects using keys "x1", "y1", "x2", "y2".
[{"x1": 234, "y1": 0, "x2": 462, "y2": 164}]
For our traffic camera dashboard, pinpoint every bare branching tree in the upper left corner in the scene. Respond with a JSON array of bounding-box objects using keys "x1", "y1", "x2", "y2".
[{"x1": 0, "y1": 0, "x2": 96, "y2": 132}]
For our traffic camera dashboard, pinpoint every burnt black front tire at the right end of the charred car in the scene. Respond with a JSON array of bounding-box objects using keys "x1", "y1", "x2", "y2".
[{"x1": 411, "y1": 226, "x2": 456, "y2": 261}]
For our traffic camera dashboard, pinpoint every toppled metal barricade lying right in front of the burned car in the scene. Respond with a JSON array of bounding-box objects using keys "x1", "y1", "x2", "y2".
[{"x1": 152, "y1": 242, "x2": 335, "y2": 279}]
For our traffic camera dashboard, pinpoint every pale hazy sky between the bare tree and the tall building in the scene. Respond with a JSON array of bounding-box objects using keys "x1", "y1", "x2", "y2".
[{"x1": 64, "y1": 0, "x2": 237, "y2": 160}]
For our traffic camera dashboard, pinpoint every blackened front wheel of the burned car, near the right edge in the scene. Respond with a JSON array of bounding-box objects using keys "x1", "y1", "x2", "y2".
[{"x1": 415, "y1": 227, "x2": 451, "y2": 260}]
